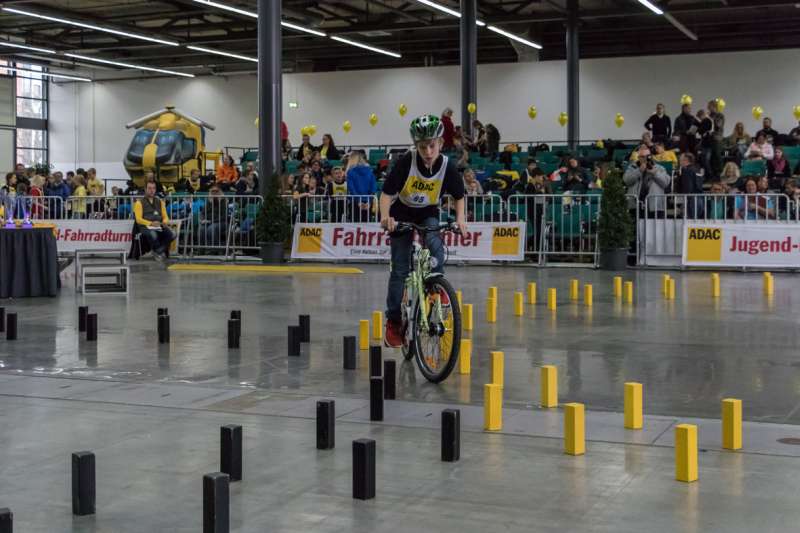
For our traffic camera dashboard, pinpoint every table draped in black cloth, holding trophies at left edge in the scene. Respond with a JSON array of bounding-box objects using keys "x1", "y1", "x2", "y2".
[{"x1": 0, "y1": 228, "x2": 60, "y2": 298}]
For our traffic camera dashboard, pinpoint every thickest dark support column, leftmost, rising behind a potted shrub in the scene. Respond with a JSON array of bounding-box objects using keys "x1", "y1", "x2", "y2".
[{"x1": 258, "y1": 0, "x2": 283, "y2": 196}]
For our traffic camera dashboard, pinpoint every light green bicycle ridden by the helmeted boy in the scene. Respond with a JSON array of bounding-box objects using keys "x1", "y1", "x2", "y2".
[{"x1": 395, "y1": 222, "x2": 461, "y2": 383}]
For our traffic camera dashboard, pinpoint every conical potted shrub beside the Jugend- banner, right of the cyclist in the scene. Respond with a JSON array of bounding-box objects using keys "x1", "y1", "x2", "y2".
[{"x1": 598, "y1": 170, "x2": 633, "y2": 270}]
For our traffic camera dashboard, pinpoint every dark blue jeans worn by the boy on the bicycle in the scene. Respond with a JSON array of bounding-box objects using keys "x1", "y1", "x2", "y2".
[{"x1": 386, "y1": 217, "x2": 444, "y2": 322}]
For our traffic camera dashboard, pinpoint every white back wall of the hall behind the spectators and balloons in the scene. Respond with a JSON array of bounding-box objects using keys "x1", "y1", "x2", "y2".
[{"x1": 50, "y1": 50, "x2": 800, "y2": 177}]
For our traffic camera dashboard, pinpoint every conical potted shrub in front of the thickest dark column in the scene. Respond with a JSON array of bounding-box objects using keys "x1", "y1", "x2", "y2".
[{"x1": 256, "y1": 175, "x2": 292, "y2": 263}]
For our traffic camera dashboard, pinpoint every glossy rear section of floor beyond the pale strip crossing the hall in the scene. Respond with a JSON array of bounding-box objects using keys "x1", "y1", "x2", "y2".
[{"x1": 0, "y1": 266, "x2": 800, "y2": 424}]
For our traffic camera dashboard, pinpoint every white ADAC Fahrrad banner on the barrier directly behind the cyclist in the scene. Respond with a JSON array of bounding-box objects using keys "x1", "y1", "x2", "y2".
[{"x1": 292, "y1": 222, "x2": 525, "y2": 261}]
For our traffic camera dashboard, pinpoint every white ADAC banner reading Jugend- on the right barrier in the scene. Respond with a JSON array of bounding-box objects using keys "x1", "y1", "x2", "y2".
[{"x1": 682, "y1": 221, "x2": 800, "y2": 268}]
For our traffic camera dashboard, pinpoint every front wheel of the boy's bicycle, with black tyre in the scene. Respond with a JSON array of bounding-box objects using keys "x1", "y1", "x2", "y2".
[{"x1": 414, "y1": 276, "x2": 461, "y2": 383}]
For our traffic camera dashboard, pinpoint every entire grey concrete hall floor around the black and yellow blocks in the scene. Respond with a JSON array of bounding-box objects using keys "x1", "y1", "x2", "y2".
[{"x1": 0, "y1": 267, "x2": 800, "y2": 532}]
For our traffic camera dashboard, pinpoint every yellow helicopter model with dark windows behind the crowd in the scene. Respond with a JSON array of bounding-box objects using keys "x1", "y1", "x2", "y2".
[{"x1": 124, "y1": 106, "x2": 222, "y2": 186}]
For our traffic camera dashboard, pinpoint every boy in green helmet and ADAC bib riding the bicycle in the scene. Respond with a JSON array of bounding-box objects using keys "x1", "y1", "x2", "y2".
[{"x1": 380, "y1": 115, "x2": 466, "y2": 348}]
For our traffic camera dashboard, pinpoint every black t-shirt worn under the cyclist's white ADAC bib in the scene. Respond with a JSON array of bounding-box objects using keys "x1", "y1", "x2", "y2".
[{"x1": 383, "y1": 150, "x2": 464, "y2": 224}]
